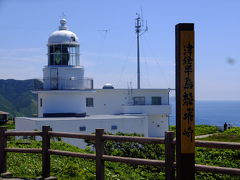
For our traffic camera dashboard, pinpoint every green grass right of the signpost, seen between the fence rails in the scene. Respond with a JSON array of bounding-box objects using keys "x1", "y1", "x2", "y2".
[{"x1": 195, "y1": 127, "x2": 240, "y2": 180}]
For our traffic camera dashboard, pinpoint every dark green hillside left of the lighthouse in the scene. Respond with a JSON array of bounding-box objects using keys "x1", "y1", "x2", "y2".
[{"x1": 0, "y1": 79, "x2": 42, "y2": 116}]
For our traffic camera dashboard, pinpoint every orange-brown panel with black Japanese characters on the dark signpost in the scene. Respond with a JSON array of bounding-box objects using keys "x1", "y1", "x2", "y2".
[{"x1": 180, "y1": 31, "x2": 195, "y2": 153}]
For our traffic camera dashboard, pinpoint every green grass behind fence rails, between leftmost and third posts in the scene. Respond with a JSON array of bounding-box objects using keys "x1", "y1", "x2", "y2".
[{"x1": 8, "y1": 140, "x2": 94, "y2": 179}]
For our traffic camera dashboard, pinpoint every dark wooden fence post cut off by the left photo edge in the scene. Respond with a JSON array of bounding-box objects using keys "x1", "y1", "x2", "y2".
[{"x1": 0, "y1": 127, "x2": 7, "y2": 174}]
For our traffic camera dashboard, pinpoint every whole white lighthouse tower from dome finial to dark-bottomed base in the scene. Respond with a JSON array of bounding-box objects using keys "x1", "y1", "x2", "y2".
[{"x1": 37, "y1": 19, "x2": 93, "y2": 117}]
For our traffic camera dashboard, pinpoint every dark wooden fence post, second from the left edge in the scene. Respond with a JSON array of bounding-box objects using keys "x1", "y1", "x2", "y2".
[{"x1": 42, "y1": 126, "x2": 51, "y2": 178}]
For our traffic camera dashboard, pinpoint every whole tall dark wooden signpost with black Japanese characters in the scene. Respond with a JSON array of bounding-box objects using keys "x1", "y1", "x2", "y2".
[{"x1": 175, "y1": 23, "x2": 195, "y2": 180}]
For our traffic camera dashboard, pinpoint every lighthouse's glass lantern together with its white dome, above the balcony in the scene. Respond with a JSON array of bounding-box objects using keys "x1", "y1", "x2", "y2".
[{"x1": 48, "y1": 19, "x2": 79, "y2": 66}]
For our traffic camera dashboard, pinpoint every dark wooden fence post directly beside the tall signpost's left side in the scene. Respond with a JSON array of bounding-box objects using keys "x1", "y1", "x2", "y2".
[{"x1": 165, "y1": 131, "x2": 175, "y2": 180}]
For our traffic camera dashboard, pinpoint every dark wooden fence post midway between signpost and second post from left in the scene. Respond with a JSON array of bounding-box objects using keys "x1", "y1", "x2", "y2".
[{"x1": 96, "y1": 129, "x2": 104, "y2": 180}]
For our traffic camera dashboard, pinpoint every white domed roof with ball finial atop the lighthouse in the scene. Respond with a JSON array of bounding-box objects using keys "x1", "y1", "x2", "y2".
[{"x1": 48, "y1": 19, "x2": 79, "y2": 45}]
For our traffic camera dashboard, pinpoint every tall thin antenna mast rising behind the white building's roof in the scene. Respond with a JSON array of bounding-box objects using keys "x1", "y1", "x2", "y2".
[{"x1": 135, "y1": 13, "x2": 148, "y2": 89}]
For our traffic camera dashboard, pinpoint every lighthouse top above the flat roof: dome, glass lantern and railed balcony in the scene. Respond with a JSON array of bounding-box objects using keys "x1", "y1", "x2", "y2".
[{"x1": 43, "y1": 19, "x2": 93, "y2": 90}]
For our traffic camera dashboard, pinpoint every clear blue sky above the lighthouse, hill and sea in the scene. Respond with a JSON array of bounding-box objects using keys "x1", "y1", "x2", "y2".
[{"x1": 0, "y1": 0, "x2": 240, "y2": 100}]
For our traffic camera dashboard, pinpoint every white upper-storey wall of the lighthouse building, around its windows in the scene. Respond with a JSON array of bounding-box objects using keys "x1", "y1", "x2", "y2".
[{"x1": 38, "y1": 89, "x2": 171, "y2": 117}]
